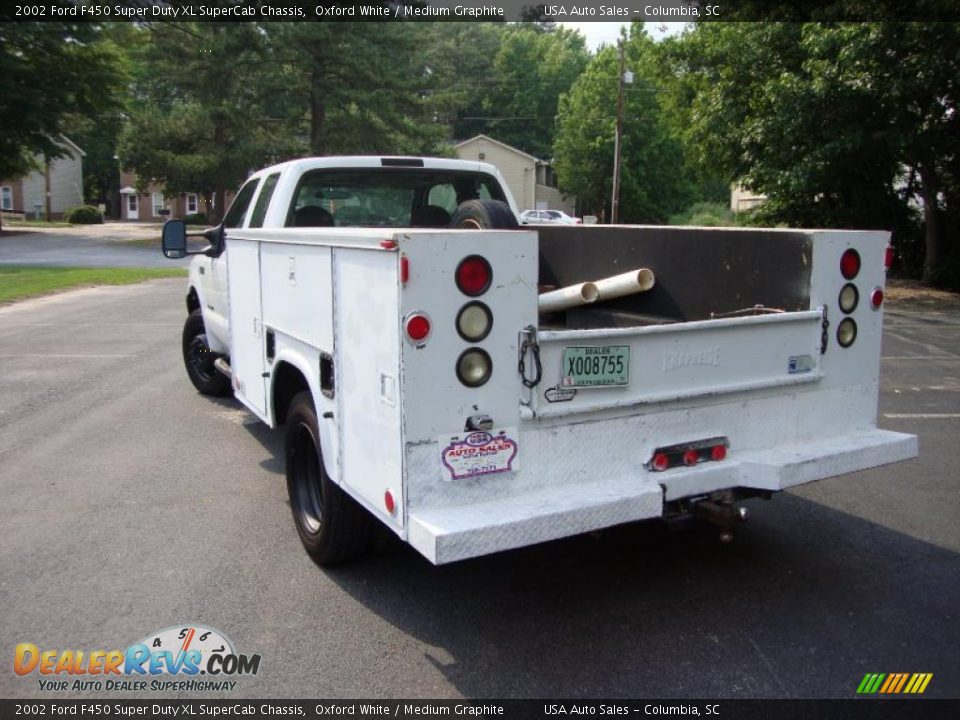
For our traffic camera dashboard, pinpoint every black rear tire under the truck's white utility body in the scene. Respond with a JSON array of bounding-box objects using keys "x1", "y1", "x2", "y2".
[{"x1": 285, "y1": 392, "x2": 370, "y2": 565}]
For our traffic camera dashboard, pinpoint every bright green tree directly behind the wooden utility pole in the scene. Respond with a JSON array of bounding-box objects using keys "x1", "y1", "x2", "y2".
[{"x1": 554, "y1": 24, "x2": 693, "y2": 223}]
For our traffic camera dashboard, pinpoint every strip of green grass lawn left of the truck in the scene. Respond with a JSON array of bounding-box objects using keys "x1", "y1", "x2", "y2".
[{"x1": 0, "y1": 265, "x2": 187, "y2": 303}]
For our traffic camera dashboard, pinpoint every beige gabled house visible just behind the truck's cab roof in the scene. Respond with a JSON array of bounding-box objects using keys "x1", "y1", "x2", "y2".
[{"x1": 454, "y1": 135, "x2": 576, "y2": 215}]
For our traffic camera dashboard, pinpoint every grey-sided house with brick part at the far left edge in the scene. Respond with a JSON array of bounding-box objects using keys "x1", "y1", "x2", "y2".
[{"x1": 0, "y1": 135, "x2": 86, "y2": 218}]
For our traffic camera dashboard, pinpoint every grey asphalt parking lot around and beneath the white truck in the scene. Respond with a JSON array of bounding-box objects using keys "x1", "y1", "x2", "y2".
[{"x1": 0, "y1": 280, "x2": 960, "y2": 698}]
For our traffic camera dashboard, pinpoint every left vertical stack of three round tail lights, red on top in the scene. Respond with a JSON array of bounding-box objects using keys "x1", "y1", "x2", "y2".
[{"x1": 454, "y1": 255, "x2": 493, "y2": 387}]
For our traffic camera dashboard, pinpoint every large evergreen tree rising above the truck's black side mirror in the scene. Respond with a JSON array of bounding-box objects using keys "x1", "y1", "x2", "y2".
[{"x1": 119, "y1": 22, "x2": 302, "y2": 219}]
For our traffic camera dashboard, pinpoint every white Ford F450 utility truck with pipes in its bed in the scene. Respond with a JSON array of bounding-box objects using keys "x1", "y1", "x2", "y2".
[{"x1": 163, "y1": 157, "x2": 917, "y2": 564}]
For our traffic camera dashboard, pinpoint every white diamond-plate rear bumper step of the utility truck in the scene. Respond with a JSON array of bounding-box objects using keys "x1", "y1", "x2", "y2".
[{"x1": 407, "y1": 430, "x2": 917, "y2": 564}]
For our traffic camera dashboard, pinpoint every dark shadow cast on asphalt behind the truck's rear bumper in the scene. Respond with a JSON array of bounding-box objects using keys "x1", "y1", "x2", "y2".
[{"x1": 316, "y1": 495, "x2": 960, "y2": 698}]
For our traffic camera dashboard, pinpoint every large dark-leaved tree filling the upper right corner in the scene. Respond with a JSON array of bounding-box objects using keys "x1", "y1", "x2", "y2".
[{"x1": 671, "y1": 23, "x2": 960, "y2": 281}]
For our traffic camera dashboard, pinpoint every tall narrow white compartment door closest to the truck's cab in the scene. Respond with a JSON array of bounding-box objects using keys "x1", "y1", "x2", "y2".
[{"x1": 227, "y1": 238, "x2": 267, "y2": 422}]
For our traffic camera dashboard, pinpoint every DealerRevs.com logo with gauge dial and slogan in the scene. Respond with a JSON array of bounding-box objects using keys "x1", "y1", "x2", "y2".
[{"x1": 13, "y1": 624, "x2": 260, "y2": 692}]
